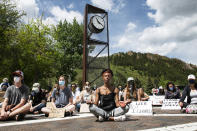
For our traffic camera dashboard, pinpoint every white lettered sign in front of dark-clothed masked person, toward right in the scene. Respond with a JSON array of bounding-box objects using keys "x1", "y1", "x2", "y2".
[{"x1": 161, "y1": 99, "x2": 181, "y2": 110}]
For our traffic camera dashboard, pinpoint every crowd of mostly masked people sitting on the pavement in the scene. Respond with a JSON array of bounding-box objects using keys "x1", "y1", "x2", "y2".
[{"x1": 0, "y1": 69, "x2": 197, "y2": 121}]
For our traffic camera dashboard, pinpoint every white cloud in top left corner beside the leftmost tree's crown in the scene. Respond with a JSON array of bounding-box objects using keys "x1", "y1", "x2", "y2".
[{"x1": 13, "y1": 0, "x2": 39, "y2": 23}]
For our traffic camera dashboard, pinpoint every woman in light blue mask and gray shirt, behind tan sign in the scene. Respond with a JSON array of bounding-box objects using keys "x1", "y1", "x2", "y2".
[{"x1": 41, "y1": 76, "x2": 75, "y2": 116}]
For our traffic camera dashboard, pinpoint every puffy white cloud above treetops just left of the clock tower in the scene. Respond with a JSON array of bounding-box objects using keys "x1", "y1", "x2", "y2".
[{"x1": 43, "y1": 6, "x2": 83, "y2": 25}]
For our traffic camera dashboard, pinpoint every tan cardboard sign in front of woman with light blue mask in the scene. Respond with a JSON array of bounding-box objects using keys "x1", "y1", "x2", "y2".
[{"x1": 47, "y1": 102, "x2": 66, "y2": 118}]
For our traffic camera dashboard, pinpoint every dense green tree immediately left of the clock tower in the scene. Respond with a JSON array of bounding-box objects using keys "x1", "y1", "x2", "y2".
[{"x1": 53, "y1": 19, "x2": 83, "y2": 80}]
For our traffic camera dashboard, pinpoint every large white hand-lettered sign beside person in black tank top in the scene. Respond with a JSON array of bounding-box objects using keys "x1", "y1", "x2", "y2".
[{"x1": 127, "y1": 101, "x2": 153, "y2": 116}]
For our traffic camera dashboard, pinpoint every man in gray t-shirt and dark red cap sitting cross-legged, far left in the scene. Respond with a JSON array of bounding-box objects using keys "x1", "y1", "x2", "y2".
[{"x1": 0, "y1": 70, "x2": 31, "y2": 120}]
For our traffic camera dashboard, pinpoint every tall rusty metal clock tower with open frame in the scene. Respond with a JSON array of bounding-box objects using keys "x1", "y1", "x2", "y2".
[{"x1": 83, "y1": 4, "x2": 110, "y2": 87}]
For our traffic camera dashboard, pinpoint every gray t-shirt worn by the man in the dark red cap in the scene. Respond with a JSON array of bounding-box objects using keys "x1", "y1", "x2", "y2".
[{"x1": 4, "y1": 85, "x2": 29, "y2": 105}]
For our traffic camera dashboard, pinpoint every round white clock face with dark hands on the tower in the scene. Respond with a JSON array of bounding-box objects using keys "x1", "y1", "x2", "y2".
[{"x1": 92, "y1": 15, "x2": 105, "y2": 30}]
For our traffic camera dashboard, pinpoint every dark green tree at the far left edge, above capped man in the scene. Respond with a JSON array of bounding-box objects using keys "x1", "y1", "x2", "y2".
[{"x1": 0, "y1": 0, "x2": 24, "y2": 78}]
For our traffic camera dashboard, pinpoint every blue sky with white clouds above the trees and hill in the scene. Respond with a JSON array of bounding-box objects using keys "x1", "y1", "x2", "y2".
[{"x1": 12, "y1": 0, "x2": 197, "y2": 65}]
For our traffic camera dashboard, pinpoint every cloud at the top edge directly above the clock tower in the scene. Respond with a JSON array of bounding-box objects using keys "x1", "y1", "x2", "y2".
[{"x1": 91, "y1": 0, "x2": 125, "y2": 13}]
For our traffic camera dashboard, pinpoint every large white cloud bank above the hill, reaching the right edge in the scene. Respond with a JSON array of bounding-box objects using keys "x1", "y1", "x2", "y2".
[{"x1": 112, "y1": 0, "x2": 197, "y2": 64}]
